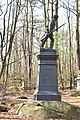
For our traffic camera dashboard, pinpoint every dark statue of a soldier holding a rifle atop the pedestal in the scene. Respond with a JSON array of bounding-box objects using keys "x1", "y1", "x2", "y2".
[{"x1": 41, "y1": 15, "x2": 58, "y2": 49}]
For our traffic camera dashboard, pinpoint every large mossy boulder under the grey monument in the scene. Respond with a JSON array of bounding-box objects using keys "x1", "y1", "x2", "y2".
[{"x1": 13, "y1": 101, "x2": 80, "y2": 120}]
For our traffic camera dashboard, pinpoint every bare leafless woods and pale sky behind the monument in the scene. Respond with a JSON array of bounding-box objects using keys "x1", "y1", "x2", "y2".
[{"x1": 0, "y1": 0, "x2": 80, "y2": 94}]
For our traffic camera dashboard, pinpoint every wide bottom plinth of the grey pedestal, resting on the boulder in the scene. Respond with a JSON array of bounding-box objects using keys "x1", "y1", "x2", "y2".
[{"x1": 33, "y1": 91, "x2": 61, "y2": 101}]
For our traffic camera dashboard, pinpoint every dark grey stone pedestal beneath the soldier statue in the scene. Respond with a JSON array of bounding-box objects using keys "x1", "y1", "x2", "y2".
[{"x1": 33, "y1": 48, "x2": 61, "y2": 101}]
